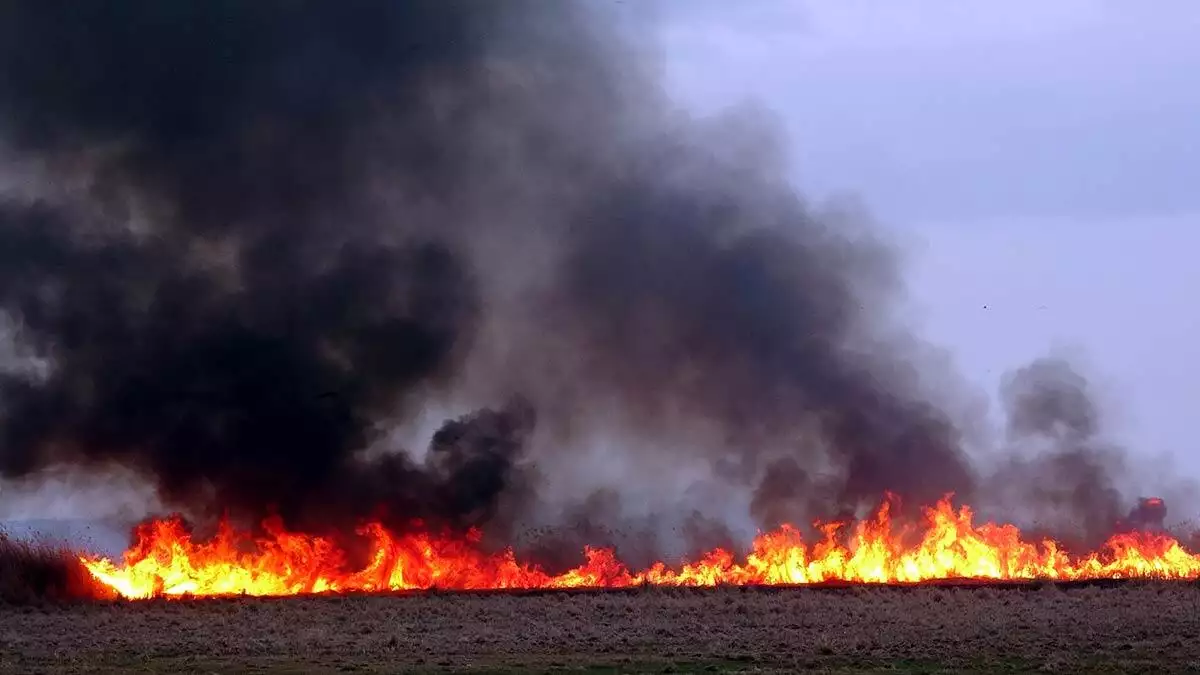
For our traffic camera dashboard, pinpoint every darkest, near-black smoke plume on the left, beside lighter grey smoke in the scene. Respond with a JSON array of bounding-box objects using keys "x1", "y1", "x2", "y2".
[{"x1": 0, "y1": 1, "x2": 556, "y2": 535}]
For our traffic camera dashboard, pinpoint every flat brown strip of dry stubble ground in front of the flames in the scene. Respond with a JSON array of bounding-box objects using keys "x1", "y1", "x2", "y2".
[{"x1": 0, "y1": 584, "x2": 1200, "y2": 674}]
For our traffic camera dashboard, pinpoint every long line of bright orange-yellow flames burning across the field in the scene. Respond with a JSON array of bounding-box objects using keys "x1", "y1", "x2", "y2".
[{"x1": 82, "y1": 497, "x2": 1200, "y2": 598}]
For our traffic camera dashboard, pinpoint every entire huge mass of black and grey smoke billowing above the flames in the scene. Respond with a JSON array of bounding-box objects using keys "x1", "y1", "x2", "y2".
[{"x1": 0, "y1": 0, "x2": 1152, "y2": 554}]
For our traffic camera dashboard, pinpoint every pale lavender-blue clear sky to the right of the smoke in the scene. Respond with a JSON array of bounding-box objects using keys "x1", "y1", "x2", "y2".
[{"x1": 661, "y1": 0, "x2": 1200, "y2": 477}]
